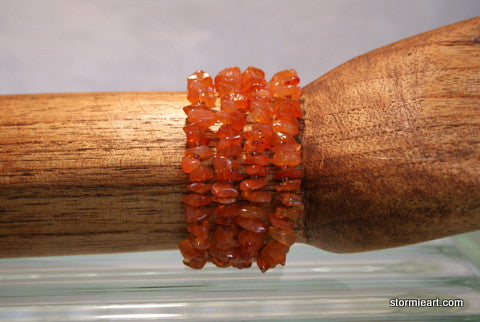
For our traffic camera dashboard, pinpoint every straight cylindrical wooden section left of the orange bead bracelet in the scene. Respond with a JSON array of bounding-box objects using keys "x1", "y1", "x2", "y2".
[{"x1": 0, "y1": 92, "x2": 304, "y2": 257}]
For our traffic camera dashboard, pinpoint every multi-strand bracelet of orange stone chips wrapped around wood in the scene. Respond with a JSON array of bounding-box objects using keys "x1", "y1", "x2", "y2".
[{"x1": 178, "y1": 67, "x2": 303, "y2": 272}]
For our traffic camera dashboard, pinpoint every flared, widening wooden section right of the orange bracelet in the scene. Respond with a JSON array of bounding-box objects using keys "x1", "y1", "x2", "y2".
[{"x1": 303, "y1": 17, "x2": 480, "y2": 252}]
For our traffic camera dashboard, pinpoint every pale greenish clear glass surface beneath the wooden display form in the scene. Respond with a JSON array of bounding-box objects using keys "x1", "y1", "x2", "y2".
[{"x1": 0, "y1": 232, "x2": 480, "y2": 321}]
